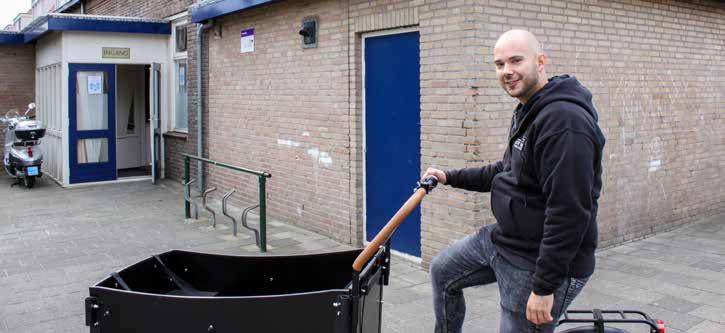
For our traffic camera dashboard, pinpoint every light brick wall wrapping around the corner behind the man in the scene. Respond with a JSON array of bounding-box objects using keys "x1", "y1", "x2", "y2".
[{"x1": 199, "y1": 0, "x2": 725, "y2": 268}]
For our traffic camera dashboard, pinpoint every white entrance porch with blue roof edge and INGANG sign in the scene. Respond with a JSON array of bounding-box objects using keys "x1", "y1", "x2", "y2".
[{"x1": 23, "y1": 14, "x2": 171, "y2": 186}]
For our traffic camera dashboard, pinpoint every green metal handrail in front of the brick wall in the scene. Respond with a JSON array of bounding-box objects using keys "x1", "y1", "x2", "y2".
[{"x1": 182, "y1": 154, "x2": 272, "y2": 253}]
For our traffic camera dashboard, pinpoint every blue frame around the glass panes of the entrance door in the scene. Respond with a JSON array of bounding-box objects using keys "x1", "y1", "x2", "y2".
[{"x1": 68, "y1": 63, "x2": 118, "y2": 185}]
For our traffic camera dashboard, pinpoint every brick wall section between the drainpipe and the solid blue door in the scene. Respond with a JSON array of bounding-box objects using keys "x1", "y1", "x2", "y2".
[{"x1": 208, "y1": 0, "x2": 355, "y2": 242}]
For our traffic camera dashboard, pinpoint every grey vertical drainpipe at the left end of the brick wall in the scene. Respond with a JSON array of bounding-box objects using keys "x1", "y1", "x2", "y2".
[{"x1": 196, "y1": 20, "x2": 214, "y2": 192}]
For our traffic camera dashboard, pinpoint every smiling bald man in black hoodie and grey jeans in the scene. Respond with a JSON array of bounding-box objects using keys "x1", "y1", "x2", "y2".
[{"x1": 424, "y1": 30, "x2": 605, "y2": 333}]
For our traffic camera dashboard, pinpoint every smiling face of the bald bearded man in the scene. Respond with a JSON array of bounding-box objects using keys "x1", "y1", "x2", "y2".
[{"x1": 493, "y1": 40, "x2": 539, "y2": 103}]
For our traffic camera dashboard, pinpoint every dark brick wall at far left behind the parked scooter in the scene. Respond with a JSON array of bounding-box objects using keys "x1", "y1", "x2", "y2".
[{"x1": 0, "y1": 44, "x2": 35, "y2": 154}]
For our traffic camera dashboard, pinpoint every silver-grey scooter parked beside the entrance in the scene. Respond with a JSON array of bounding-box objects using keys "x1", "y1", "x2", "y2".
[{"x1": 0, "y1": 103, "x2": 45, "y2": 188}]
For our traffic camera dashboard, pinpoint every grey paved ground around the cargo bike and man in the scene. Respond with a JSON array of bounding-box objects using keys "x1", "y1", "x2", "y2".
[{"x1": 0, "y1": 175, "x2": 725, "y2": 333}]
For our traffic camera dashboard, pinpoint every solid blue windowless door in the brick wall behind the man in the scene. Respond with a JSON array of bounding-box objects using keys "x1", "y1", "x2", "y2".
[{"x1": 364, "y1": 32, "x2": 420, "y2": 257}]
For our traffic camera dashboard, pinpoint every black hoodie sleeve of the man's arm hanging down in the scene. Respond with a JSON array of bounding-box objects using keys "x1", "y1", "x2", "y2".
[{"x1": 533, "y1": 128, "x2": 597, "y2": 295}]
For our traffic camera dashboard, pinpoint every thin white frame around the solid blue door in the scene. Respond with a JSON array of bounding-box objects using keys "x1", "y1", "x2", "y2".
[{"x1": 360, "y1": 26, "x2": 423, "y2": 263}]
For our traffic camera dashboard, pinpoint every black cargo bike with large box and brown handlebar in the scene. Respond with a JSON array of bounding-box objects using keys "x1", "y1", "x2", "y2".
[{"x1": 85, "y1": 177, "x2": 664, "y2": 333}]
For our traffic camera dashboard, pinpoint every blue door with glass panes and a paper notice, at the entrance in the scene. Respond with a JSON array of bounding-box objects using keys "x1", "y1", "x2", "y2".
[{"x1": 68, "y1": 64, "x2": 116, "y2": 184}]
